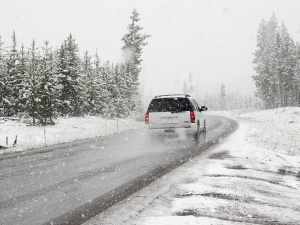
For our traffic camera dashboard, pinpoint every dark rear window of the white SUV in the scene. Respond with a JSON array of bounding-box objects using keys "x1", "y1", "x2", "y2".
[{"x1": 148, "y1": 98, "x2": 193, "y2": 112}]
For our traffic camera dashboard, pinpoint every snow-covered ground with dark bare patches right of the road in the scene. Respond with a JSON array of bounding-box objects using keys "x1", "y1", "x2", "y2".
[{"x1": 85, "y1": 108, "x2": 300, "y2": 225}]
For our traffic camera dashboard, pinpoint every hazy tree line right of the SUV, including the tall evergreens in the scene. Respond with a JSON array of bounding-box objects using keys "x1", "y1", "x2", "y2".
[{"x1": 182, "y1": 14, "x2": 300, "y2": 111}]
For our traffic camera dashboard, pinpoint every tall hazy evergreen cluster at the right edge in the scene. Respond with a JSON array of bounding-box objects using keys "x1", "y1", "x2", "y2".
[{"x1": 253, "y1": 14, "x2": 300, "y2": 109}]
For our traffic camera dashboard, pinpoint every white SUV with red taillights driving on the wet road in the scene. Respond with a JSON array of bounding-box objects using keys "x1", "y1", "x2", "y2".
[{"x1": 145, "y1": 94, "x2": 207, "y2": 133}]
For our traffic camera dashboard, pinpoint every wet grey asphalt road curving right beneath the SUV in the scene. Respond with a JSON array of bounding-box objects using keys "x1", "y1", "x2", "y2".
[{"x1": 0, "y1": 116, "x2": 237, "y2": 225}]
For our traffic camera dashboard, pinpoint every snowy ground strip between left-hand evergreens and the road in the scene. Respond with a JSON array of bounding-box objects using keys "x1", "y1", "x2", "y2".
[{"x1": 0, "y1": 116, "x2": 144, "y2": 154}]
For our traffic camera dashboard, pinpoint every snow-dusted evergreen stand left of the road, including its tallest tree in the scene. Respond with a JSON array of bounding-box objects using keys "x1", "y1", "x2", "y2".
[{"x1": 0, "y1": 10, "x2": 149, "y2": 125}]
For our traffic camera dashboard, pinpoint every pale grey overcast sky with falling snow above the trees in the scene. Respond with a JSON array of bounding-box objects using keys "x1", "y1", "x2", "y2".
[{"x1": 0, "y1": 0, "x2": 300, "y2": 101}]
